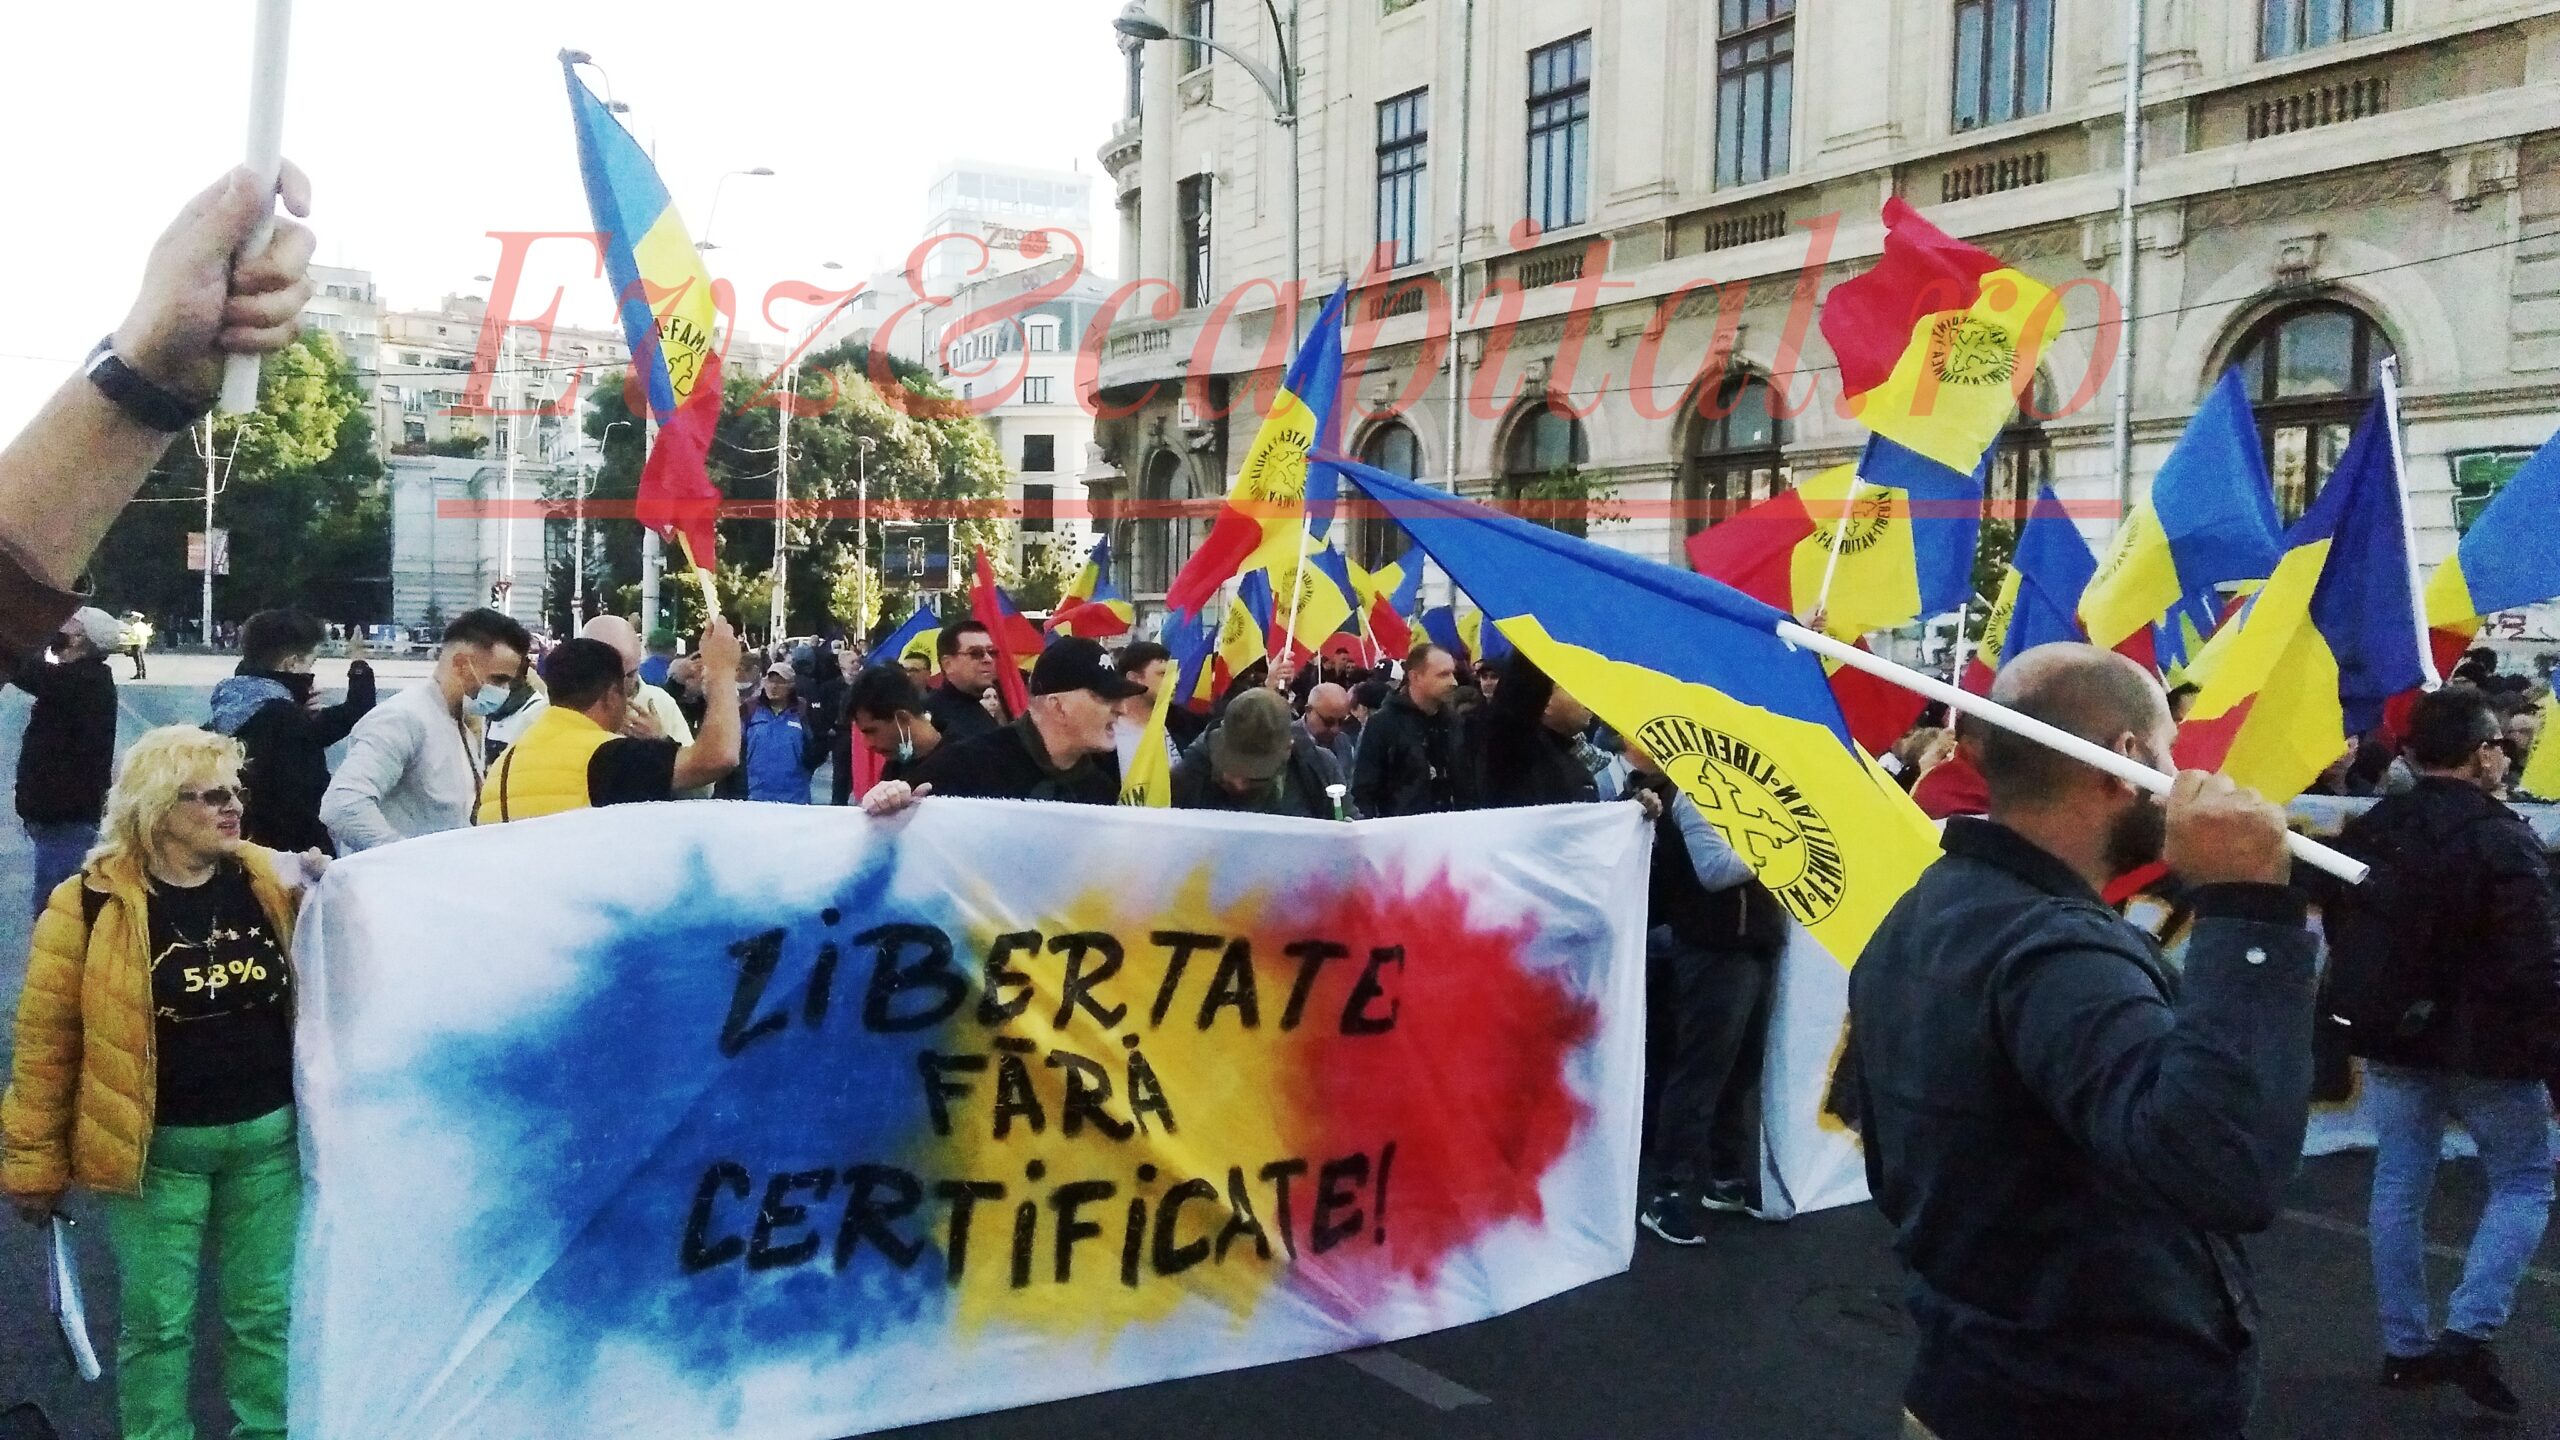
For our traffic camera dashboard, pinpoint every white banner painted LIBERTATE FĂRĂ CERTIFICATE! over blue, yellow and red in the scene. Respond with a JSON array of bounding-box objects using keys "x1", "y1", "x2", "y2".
[{"x1": 289, "y1": 799, "x2": 1651, "y2": 1440}]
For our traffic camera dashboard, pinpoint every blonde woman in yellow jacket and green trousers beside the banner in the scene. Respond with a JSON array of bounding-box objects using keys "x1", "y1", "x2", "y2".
[{"x1": 0, "y1": 725, "x2": 328, "y2": 1440}]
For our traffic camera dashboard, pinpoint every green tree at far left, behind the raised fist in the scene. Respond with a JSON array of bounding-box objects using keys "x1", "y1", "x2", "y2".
[{"x1": 90, "y1": 331, "x2": 392, "y2": 623}]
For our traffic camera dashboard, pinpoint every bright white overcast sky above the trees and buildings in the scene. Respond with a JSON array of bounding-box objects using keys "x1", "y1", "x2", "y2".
[{"x1": 0, "y1": 0, "x2": 1121, "y2": 436}]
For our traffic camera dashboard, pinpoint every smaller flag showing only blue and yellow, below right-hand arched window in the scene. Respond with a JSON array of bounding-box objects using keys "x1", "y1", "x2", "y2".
[{"x1": 2079, "y1": 369, "x2": 2284, "y2": 666}]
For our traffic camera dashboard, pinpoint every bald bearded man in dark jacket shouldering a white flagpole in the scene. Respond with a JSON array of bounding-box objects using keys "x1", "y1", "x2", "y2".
[{"x1": 1843, "y1": 646, "x2": 2317, "y2": 1440}]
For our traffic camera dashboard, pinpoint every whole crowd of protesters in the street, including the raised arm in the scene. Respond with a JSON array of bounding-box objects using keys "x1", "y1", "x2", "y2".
[{"x1": 0, "y1": 156, "x2": 2560, "y2": 1440}]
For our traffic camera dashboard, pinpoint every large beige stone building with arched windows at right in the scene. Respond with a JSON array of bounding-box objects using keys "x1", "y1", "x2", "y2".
[{"x1": 1085, "y1": 0, "x2": 2560, "y2": 638}]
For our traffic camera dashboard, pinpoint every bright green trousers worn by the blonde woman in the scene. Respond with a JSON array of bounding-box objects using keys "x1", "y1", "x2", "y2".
[{"x1": 105, "y1": 1104, "x2": 302, "y2": 1440}]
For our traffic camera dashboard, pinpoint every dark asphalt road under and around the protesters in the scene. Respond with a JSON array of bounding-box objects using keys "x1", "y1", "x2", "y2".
[{"x1": 0, "y1": 664, "x2": 2560, "y2": 1440}]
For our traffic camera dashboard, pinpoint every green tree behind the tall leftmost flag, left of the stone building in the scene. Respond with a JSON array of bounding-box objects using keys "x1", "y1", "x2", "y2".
[{"x1": 586, "y1": 346, "x2": 1014, "y2": 633}]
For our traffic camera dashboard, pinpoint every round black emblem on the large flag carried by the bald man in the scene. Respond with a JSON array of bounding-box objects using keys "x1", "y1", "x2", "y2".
[{"x1": 1636, "y1": 715, "x2": 1848, "y2": 925}]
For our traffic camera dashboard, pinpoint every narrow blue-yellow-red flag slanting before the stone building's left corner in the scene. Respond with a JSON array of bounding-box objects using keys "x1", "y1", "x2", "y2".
[{"x1": 1165, "y1": 290, "x2": 1349, "y2": 615}]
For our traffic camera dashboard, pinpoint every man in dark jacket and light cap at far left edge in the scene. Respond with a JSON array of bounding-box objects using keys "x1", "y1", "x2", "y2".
[{"x1": 8, "y1": 605, "x2": 125, "y2": 915}]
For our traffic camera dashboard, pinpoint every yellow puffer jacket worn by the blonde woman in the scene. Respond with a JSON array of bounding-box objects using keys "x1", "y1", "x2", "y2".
[{"x1": 0, "y1": 846, "x2": 300, "y2": 1197}]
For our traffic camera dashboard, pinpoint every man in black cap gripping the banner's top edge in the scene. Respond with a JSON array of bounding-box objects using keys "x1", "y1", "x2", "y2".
[{"x1": 890, "y1": 635, "x2": 1147, "y2": 799}]
